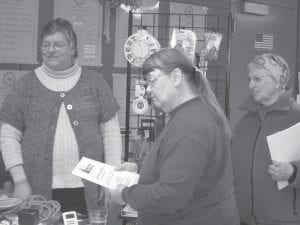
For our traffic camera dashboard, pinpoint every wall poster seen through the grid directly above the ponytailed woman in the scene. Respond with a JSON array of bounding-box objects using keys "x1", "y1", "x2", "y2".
[{"x1": 169, "y1": 2, "x2": 208, "y2": 52}]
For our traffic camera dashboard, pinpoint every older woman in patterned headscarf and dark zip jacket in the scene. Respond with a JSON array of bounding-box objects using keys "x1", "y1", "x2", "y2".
[{"x1": 232, "y1": 53, "x2": 300, "y2": 225}]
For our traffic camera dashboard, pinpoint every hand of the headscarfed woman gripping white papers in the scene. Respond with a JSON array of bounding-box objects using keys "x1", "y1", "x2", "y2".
[{"x1": 269, "y1": 161, "x2": 294, "y2": 182}]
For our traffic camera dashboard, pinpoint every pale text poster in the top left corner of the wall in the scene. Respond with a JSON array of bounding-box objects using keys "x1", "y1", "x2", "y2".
[{"x1": 0, "y1": 0, "x2": 39, "y2": 64}]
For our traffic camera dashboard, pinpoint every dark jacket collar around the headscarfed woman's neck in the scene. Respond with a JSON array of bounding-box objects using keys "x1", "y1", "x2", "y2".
[{"x1": 239, "y1": 88, "x2": 293, "y2": 113}]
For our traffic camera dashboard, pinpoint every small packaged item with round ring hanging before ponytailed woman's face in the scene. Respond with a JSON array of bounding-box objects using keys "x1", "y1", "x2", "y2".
[{"x1": 132, "y1": 80, "x2": 149, "y2": 114}]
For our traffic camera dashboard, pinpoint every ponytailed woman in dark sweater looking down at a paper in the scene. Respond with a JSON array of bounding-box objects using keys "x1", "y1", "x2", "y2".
[{"x1": 111, "y1": 48, "x2": 239, "y2": 225}]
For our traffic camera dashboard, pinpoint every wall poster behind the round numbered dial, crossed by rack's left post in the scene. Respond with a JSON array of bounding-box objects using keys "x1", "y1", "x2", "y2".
[{"x1": 114, "y1": 7, "x2": 159, "y2": 67}]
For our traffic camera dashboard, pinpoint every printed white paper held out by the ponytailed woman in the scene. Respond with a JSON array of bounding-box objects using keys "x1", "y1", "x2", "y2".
[{"x1": 72, "y1": 157, "x2": 139, "y2": 189}]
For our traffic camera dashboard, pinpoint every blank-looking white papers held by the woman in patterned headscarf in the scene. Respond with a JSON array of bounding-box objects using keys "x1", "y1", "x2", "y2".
[{"x1": 267, "y1": 123, "x2": 300, "y2": 190}]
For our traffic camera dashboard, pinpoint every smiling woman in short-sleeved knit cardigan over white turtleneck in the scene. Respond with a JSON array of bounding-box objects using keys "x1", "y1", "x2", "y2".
[{"x1": 0, "y1": 18, "x2": 121, "y2": 214}]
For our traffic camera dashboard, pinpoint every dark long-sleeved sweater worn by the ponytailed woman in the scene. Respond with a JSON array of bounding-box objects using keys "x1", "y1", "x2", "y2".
[{"x1": 122, "y1": 98, "x2": 239, "y2": 225}]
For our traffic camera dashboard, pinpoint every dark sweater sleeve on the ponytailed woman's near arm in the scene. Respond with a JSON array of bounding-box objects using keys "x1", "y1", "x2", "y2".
[{"x1": 122, "y1": 125, "x2": 208, "y2": 213}]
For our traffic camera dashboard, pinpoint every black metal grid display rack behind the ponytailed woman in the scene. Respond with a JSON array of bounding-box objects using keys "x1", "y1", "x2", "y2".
[{"x1": 124, "y1": 9, "x2": 232, "y2": 161}]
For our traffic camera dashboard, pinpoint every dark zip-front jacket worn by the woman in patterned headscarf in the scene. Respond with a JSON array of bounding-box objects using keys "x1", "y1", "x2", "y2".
[{"x1": 232, "y1": 90, "x2": 300, "y2": 225}]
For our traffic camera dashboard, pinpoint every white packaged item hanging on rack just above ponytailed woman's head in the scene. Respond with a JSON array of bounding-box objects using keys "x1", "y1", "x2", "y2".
[{"x1": 170, "y1": 28, "x2": 197, "y2": 62}]
